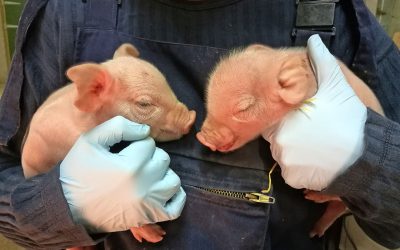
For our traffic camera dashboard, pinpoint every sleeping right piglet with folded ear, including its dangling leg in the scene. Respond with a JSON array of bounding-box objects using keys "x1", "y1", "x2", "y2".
[{"x1": 197, "y1": 44, "x2": 383, "y2": 236}]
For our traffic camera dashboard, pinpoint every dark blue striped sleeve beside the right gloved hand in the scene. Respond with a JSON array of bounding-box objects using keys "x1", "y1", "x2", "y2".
[{"x1": 324, "y1": 110, "x2": 400, "y2": 248}]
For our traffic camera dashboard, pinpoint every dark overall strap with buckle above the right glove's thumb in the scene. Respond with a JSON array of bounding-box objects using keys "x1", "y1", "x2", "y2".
[{"x1": 292, "y1": 0, "x2": 339, "y2": 47}]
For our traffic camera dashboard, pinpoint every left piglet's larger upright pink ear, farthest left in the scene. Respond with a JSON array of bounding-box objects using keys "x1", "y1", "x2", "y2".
[{"x1": 67, "y1": 63, "x2": 113, "y2": 112}]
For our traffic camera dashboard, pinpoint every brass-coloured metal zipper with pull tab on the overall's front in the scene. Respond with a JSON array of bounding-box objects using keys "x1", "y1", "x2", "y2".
[{"x1": 195, "y1": 163, "x2": 277, "y2": 204}]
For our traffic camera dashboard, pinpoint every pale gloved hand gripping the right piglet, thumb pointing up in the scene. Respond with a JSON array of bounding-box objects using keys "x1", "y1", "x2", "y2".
[{"x1": 263, "y1": 35, "x2": 367, "y2": 191}]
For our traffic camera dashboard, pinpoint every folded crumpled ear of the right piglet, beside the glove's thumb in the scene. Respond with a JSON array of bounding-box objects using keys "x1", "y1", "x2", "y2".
[{"x1": 278, "y1": 56, "x2": 317, "y2": 105}]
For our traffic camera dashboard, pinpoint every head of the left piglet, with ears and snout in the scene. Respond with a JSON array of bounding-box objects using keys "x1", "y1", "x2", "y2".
[{"x1": 67, "y1": 44, "x2": 196, "y2": 141}]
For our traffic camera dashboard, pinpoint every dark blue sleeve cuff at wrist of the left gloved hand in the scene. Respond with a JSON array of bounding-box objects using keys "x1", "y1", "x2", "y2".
[{"x1": 11, "y1": 166, "x2": 95, "y2": 249}]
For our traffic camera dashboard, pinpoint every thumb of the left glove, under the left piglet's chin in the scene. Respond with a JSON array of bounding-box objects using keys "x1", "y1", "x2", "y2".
[{"x1": 86, "y1": 116, "x2": 150, "y2": 148}]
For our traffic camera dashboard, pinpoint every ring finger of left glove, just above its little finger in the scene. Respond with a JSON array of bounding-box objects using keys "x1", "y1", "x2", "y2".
[{"x1": 151, "y1": 169, "x2": 181, "y2": 205}]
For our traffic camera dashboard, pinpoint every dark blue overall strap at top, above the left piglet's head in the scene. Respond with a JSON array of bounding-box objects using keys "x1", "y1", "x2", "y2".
[{"x1": 82, "y1": 0, "x2": 122, "y2": 29}]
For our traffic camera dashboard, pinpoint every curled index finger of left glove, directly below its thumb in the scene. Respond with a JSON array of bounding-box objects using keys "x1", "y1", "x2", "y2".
[{"x1": 117, "y1": 137, "x2": 156, "y2": 166}]
